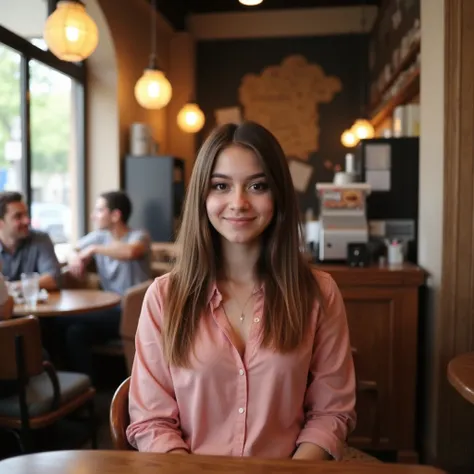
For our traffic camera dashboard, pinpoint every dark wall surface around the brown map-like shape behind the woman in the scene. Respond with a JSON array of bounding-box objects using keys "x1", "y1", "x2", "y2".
[{"x1": 196, "y1": 35, "x2": 368, "y2": 212}]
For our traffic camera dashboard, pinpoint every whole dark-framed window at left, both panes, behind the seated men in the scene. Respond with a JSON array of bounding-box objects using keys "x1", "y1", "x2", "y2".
[{"x1": 0, "y1": 6, "x2": 85, "y2": 244}]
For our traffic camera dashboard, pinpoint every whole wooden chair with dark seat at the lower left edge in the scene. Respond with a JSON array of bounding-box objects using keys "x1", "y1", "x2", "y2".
[{"x1": 0, "y1": 316, "x2": 97, "y2": 452}]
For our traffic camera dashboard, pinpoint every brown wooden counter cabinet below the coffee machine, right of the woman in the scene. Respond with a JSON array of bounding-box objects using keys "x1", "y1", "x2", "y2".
[{"x1": 318, "y1": 265, "x2": 425, "y2": 462}]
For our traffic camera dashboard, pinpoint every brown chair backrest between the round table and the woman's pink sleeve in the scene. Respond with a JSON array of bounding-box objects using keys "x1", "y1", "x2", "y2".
[{"x1": 120, "y1": 280, "x2": 152, "y2": 374}]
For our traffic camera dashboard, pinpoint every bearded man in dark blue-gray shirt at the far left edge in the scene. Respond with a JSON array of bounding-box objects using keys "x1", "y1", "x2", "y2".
[{"x1": 0, "y1": 191, "x2": 60, "y2": 290}]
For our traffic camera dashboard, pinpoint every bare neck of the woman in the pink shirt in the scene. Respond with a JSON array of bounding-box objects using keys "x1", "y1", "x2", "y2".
[{"x1": 221, "y1": 242, "x2": 261, "y2": 286}]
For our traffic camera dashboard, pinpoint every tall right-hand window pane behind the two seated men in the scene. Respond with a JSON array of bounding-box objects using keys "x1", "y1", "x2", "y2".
[{"x1": 30, "y1": 60, "x2": 78, "y2": 243}]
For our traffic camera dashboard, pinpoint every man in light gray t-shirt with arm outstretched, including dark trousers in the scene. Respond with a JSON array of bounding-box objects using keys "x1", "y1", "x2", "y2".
[{"x1": 62, "y1": 191, "x2": 150, "y2": 375}]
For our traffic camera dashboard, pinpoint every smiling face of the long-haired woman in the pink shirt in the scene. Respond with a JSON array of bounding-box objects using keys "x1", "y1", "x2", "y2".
[{"x1": 206, "y1": 146, "x2": 274, "y2": 244}]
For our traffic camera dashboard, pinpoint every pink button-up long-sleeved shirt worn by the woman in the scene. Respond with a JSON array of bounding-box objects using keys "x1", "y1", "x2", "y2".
[{"x1": 127, "y1": 271, "x2": 355, "y2": 459}]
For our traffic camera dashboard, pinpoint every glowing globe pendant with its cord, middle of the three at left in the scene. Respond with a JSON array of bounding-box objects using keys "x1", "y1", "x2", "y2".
[{"x1": 135, "y1": 0, "x2": 173, "y2": 110}]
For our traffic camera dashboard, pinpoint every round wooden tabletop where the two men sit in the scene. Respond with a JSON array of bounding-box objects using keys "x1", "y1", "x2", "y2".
[{"x1": 13, "y1": 290, "x2": 122, "y2": 317}]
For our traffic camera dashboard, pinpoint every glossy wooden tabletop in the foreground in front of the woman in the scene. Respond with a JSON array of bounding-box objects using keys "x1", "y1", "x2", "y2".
[{"x1": 0, "y1": 451, "x2": 443, "y2": 474}]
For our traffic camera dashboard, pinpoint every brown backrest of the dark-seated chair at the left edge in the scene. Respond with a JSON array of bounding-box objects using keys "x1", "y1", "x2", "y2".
[{"x1": 0, "y1": 316, "x2": 44, "y2": 380}]
